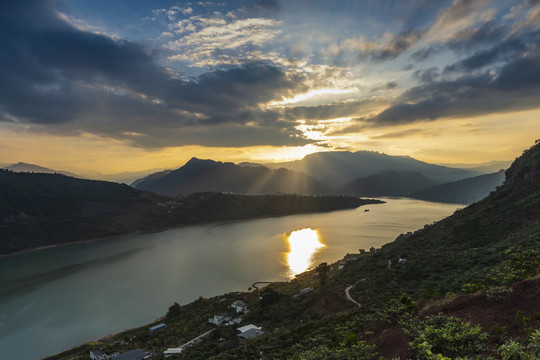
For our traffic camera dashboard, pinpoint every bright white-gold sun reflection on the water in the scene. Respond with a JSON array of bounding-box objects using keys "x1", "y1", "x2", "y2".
[{"x1": 287, "y1": 228, "x2": 325, "y2": 276}]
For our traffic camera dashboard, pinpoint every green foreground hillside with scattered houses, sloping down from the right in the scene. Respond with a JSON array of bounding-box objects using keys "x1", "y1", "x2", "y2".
[{"x1": 47, "y1": 144, "x2": 540, "y2": 360}]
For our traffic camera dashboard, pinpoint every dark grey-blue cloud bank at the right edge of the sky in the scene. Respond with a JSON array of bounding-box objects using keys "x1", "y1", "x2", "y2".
[{"x1": 370, "y1": 53, "x2": 540, "y2": 126}]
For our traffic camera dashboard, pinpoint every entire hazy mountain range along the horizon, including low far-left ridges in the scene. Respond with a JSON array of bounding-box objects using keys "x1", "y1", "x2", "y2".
[{"x1": 4, "y1": 151, "x2": 509, "y2": 203}]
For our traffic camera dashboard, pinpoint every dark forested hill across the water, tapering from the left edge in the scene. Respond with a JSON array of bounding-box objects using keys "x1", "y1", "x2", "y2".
[{"x1": 0, "y1": 170, "x2": 377, "y2": 254}]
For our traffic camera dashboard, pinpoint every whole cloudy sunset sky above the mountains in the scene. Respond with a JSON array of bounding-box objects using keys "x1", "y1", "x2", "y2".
[{"x1": 0, "y1": 0, "x2": 540, "y2": 173}]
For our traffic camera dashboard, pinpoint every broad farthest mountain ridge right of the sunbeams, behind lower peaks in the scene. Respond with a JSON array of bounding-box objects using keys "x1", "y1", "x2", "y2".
[{"x1": 266, "y1": 151, "x2": 479, "y2": 188}]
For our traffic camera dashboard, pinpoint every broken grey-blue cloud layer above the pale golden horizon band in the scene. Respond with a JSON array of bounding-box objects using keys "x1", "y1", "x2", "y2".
[{"x1": 0, "y1": 0, "x2": 540, "y2": 148}]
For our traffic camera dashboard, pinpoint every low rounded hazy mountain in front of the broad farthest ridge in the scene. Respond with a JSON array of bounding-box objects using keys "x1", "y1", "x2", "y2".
[{"x1": 337, "y1": 171, "x2": 438, "y2": 196}]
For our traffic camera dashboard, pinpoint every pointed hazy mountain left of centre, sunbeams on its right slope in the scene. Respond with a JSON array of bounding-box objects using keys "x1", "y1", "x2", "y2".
[{"x1": 133, "y1": 158, "x2": 331, "y2": 196}]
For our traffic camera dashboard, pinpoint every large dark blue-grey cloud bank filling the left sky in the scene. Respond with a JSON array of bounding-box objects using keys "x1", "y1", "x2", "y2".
[{"x1": 0, "y1": 0, "x2": 306, "y2": 146}]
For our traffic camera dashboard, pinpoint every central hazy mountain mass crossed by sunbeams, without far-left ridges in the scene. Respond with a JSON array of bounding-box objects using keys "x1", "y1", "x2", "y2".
[{"x1": 131, "y1": 151, "x2": 488, "y2": 196}]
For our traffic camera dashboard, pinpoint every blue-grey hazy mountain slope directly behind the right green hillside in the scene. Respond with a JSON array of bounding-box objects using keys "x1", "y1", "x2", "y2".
[{"x1": 409, "y1": 170, "x2": 504, "y2": 204}]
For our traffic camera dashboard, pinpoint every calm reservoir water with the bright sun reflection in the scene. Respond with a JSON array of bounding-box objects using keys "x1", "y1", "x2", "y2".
[{"x1": 0, "y1": 198, "x2": 460, "y2": 360}]
